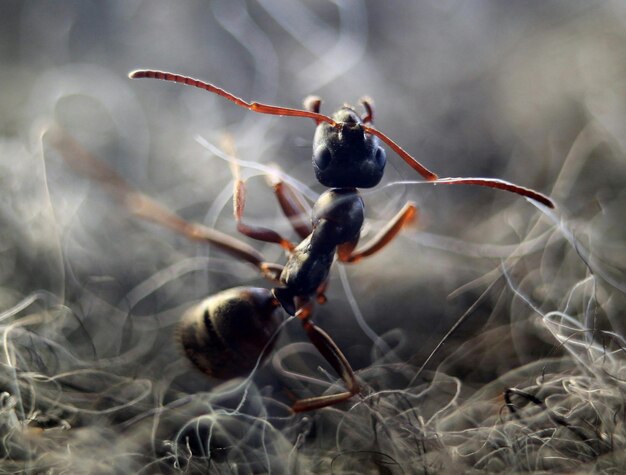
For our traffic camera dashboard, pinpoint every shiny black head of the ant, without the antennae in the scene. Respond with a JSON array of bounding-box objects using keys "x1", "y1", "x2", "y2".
[{"x1": 313, "y1": 107, "x2": 387, "y2": 188}]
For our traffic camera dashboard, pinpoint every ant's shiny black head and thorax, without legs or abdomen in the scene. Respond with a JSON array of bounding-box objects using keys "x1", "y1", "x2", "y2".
[{"x1": 274, "y1": 108, "x2": 387, "y2": 315}]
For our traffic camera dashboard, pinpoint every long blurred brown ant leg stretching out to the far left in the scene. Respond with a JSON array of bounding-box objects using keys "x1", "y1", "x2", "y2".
[{"x1": 46, "y1": 125, "x2": 282, "y2": 281}]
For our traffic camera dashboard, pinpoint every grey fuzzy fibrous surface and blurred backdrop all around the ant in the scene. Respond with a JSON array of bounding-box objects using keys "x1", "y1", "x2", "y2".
[{"x1": 0, "y1": 0, "x2": 626, "y2": 475}]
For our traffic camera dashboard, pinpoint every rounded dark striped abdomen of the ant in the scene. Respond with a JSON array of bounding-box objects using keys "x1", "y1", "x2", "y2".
[{"x1": 179, "y1": 287, "x2": 281, "y2": 379}]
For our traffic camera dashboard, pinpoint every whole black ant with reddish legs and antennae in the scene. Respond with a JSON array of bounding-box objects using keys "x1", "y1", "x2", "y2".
[{"x1": 51, "y1": 70, "x2": 554, "y2": 412}]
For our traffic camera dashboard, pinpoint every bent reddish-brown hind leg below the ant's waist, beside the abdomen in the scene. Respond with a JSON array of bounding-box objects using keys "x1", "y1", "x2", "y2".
[{"x1": 292, "y1": 304, "x2": 360, "y2": 412}]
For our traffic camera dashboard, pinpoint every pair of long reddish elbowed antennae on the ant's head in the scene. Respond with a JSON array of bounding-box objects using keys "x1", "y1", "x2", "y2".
[{"x1": 128, "y1": 69, "x2": 554, "y2": 208}]
